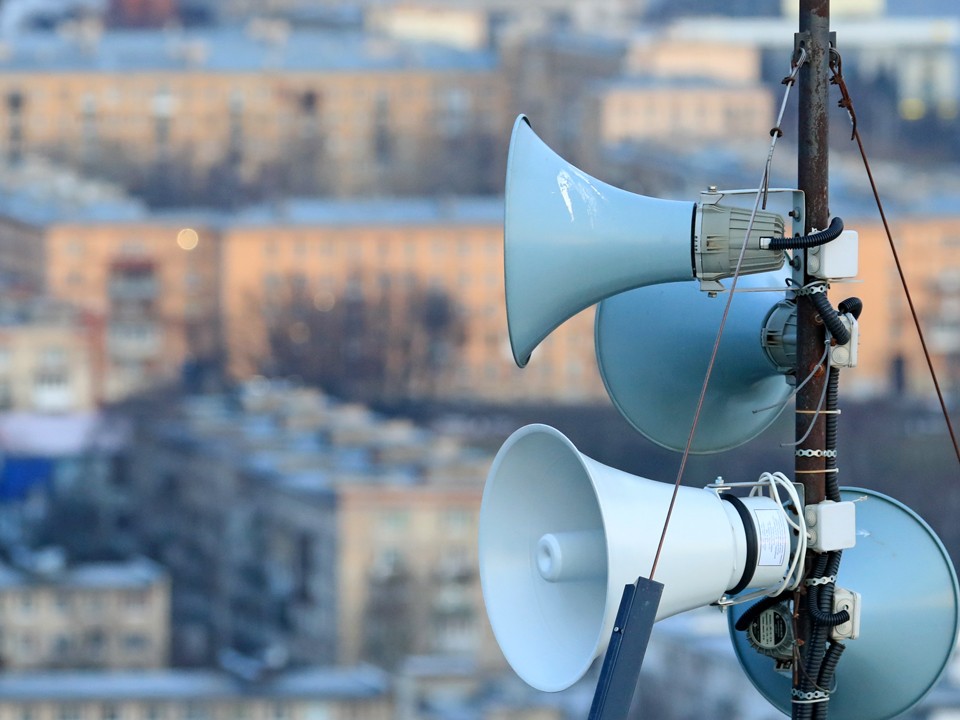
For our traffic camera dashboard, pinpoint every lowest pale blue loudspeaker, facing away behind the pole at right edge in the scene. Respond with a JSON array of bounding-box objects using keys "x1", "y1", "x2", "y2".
[{"x1": 729, "y1": 488, "x2": 960, "y2": 720}]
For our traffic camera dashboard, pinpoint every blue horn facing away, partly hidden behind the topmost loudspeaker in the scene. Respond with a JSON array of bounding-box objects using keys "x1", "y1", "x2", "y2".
[{"x1": 594, "y1": 272, "x2": 792, "y2": 453}]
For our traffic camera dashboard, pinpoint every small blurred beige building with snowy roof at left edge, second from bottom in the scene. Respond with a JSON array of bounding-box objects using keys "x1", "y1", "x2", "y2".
[{"x1": 0, "y1": 551, "x2": 170, "y2": 668}]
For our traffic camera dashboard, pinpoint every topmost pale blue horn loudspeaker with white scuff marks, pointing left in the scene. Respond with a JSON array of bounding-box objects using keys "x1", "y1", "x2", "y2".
[{"x1": 504, "y1": 115, "x2": 784, "y2": 367}]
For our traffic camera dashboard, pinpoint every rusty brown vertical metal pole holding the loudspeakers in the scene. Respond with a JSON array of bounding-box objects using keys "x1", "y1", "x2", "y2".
[{"x1": 793, "y1": 0, "x2": 830, "y2": 709}]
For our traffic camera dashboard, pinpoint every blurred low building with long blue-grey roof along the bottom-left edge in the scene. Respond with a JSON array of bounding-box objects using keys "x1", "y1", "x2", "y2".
[{"x1": 0, "y1": 666, "x2": 393, "y2": 720}]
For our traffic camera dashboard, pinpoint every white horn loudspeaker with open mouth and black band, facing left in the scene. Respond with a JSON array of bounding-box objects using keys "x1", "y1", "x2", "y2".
[{"x1": 479, "y1": 425, "x2": 791, "y2": 691}]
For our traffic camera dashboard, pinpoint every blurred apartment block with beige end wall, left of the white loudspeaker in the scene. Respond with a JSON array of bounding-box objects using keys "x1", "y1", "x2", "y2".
[{"x1": 130, "y1": 382, "x2": 498, "y2": 665}]
